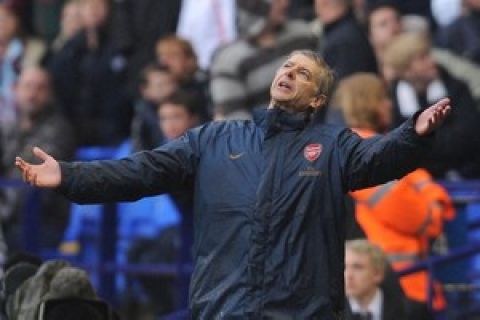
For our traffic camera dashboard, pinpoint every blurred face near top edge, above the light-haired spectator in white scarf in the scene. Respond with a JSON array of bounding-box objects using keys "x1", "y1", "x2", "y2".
[{"x1": 369, "y1": 7, "x2": 402, "y2": 48}]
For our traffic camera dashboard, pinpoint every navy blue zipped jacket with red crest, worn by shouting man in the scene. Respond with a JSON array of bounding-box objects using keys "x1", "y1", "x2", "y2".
[{"x1": 60, "y1": 109, "x2": 430, "y2": 320}]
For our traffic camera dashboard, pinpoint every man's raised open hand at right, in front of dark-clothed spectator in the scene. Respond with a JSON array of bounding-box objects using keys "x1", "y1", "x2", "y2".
[{"x1": 415, "y1": 98, "x2": 452, "y2": 136}]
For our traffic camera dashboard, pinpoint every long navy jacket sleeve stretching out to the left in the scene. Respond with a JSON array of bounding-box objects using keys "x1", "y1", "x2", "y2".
[{"x1": 59, "y1": 127, "x2": 204, "y2": 203}]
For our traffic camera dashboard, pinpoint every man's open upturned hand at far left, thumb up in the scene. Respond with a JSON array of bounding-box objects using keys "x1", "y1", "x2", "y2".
[{"x1": 15, "y1": 147, "x2": 62, "y2": 188}]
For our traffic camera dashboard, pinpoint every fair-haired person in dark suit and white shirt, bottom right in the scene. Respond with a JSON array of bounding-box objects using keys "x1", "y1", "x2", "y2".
[{"x1": 345, "y1": 240, "x2": 408, "y2": 320}]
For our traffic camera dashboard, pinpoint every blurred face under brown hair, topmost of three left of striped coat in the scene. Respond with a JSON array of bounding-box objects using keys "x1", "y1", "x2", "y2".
[{"x1": 156, "y1": 40, "x2": 196, "y2": 80}]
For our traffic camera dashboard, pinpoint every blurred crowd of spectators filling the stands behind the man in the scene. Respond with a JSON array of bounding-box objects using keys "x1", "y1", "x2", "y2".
[{"x1": 0, "y1": 0, "x2": 480, "y2": 318}]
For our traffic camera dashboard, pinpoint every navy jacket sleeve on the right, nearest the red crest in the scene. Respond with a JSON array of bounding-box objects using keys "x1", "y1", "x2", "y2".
[{"x1": 338, "y1": 113, "x2": 434, "y2": 192}]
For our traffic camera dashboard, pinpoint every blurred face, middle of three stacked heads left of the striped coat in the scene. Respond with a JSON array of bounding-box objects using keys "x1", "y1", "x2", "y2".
[{"x1": 141, "y1": 70, "x2": 177, "y2": 104}]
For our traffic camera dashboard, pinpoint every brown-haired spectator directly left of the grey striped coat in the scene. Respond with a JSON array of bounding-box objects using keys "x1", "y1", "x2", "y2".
[{"x1": 155, "y1": 35, "x2": 210, "y2": 122}]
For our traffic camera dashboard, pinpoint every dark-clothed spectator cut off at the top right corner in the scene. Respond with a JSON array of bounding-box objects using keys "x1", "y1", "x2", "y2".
[{"x1": 437, "y1": 0, "x2": 480, "y2": 64}]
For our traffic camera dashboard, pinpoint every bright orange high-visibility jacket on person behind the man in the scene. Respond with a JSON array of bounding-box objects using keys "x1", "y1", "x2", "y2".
[{"x1": 351, "y1": 130, "x2": 455, "y2": 310}]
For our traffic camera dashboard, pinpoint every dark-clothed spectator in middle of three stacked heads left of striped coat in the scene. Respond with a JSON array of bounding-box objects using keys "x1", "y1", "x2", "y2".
[{"x1": 131, "y1": 64, "x2": 177, "y2": 151}]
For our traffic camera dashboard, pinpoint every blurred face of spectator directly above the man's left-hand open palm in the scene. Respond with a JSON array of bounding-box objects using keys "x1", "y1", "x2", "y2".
[{"x1": 15, "y1": 68, "x2": 52, "y2": 114}]
